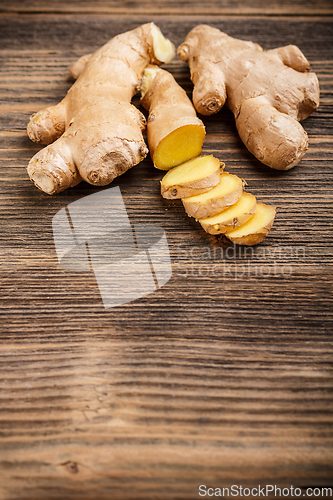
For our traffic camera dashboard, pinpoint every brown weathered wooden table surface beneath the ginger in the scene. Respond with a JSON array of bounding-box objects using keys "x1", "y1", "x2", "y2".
[{"x1": 0, "y1": 0, "x2": 333, "y2": 500}]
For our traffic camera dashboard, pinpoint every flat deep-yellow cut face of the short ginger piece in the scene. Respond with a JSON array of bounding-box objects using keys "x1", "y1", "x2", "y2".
[{"x1": 153, "y1": 125, "x2": 205, "y2": 170}]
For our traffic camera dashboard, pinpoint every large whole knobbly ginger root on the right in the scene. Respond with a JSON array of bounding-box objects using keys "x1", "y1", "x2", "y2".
[{"x1": 178, "y1": 25, "x2": 319, "y2": 170}]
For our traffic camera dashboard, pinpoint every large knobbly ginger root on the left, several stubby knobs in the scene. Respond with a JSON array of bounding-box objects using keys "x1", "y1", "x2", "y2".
[{"x1": 27, "y1": 23, "x2": 175, "y2": 194}]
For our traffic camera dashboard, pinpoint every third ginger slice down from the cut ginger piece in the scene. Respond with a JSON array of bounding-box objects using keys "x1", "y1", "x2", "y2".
[{"x1": 199, "y1": 191, "x2": 257, "y2": 234}]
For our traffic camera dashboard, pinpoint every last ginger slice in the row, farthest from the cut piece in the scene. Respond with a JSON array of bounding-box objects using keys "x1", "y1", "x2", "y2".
[{"x1": 226, "y1": 203, "x2": 276, "y2": 245}]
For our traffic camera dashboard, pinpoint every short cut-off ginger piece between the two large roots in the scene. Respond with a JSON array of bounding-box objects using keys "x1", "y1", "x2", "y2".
[{"x1": 141, "y1": 66, "x2": 205, "y2": 170}]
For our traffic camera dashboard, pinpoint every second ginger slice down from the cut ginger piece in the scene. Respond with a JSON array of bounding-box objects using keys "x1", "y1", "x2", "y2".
[{"x1": 182, "y1": 172, "x2": 243, "y2": 219}]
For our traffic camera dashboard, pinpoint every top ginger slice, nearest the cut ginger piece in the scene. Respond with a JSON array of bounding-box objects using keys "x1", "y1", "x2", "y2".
[{"x1": 161, "y1": 155, "x2": 221, "y2": 199}]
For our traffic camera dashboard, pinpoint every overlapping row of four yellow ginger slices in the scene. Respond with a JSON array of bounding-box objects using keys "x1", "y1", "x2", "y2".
[{"x1": 161, "y1": 155, "x2": 276, "y2": 245}]
